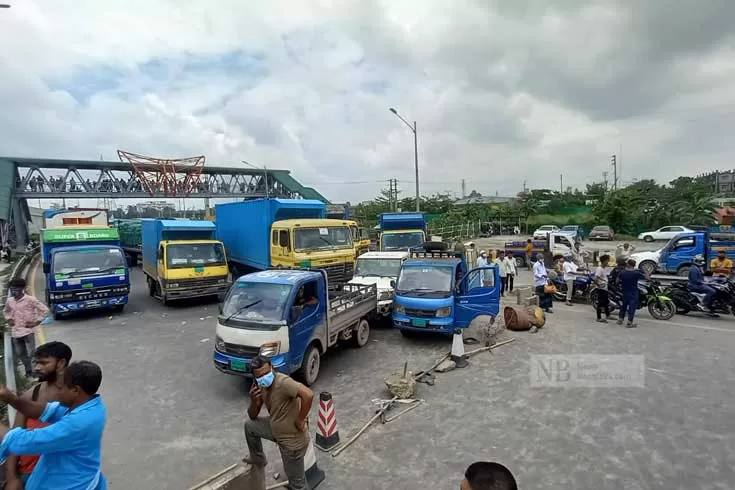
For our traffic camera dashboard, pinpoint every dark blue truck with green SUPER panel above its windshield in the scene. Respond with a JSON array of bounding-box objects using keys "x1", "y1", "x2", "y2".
[{"x1": 41, "y1": 226, "x2": 130, "y2": 318}]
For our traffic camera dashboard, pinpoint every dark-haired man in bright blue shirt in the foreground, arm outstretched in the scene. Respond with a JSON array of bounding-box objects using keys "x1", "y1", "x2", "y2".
[{"x1": 0, "y1": 361, "x2": 107, "y2": 490}]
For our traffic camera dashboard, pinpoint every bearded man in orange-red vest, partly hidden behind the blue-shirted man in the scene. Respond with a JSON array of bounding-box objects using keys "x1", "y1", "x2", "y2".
[{"x1": 5, "y1": 342, "x2": 71, "y2": 490}]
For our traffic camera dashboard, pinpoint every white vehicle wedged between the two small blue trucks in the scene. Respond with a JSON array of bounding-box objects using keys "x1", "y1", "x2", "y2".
[{"x1": 348, "y1": 252, "x2": 410, "y2": 320}]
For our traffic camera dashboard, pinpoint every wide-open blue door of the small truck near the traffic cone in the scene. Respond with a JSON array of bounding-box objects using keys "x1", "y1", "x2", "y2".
[{"x1": 454, "y1": 266, "x2": 500, "y2": 328}]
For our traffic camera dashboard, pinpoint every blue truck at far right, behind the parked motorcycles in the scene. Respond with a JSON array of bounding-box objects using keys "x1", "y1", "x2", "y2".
[{"x1": 658, "y1": 231, "x2": 735, "y2": 276}]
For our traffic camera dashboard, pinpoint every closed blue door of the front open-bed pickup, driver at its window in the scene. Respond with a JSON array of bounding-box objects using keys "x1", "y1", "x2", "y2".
[{"x1": 288, "y1": 281, "x2": 328, "y2": 366}]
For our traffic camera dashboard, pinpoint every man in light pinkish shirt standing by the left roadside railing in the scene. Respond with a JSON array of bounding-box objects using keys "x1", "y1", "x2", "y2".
[{"x1": 3, "y1": 278, "x2": 48, "y2": 378}]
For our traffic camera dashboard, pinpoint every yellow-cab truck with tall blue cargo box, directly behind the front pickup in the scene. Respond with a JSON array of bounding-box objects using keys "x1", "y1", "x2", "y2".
[{"x1": 216, "y1": 199, "x2": 355, "y2": 287}]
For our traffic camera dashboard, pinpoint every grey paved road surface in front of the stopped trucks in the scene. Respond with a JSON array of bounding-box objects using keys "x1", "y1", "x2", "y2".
[{"x1": 31, "y1": 264, "x2": 735, "y2": 490}]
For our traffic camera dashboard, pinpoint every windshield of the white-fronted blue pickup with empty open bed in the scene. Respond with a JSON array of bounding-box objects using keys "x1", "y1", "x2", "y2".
[{"x1": 220, "y1": 281, "x2": 292, "y2": 326}]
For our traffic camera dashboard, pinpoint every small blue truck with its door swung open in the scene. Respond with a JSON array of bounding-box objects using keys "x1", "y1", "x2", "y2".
[{"x1": 393, "y1": 252, "x2": 500, "y2": 335}]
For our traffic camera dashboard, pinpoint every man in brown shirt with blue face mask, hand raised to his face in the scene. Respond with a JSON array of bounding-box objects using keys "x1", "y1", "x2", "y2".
[{"x1": 243, "y1": 356, "x2": 314, "y2": 490}]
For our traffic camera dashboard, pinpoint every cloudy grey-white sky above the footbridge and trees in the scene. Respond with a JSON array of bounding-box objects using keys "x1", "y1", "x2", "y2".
[{"x1": 0, "y1": 0, "x2": 735, "y2": 202}]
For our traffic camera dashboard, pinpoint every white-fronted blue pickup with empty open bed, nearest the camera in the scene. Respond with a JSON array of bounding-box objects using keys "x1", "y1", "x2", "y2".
[{"x1": 214, "y1": 270, "x2": 378, "y2": 386}]
